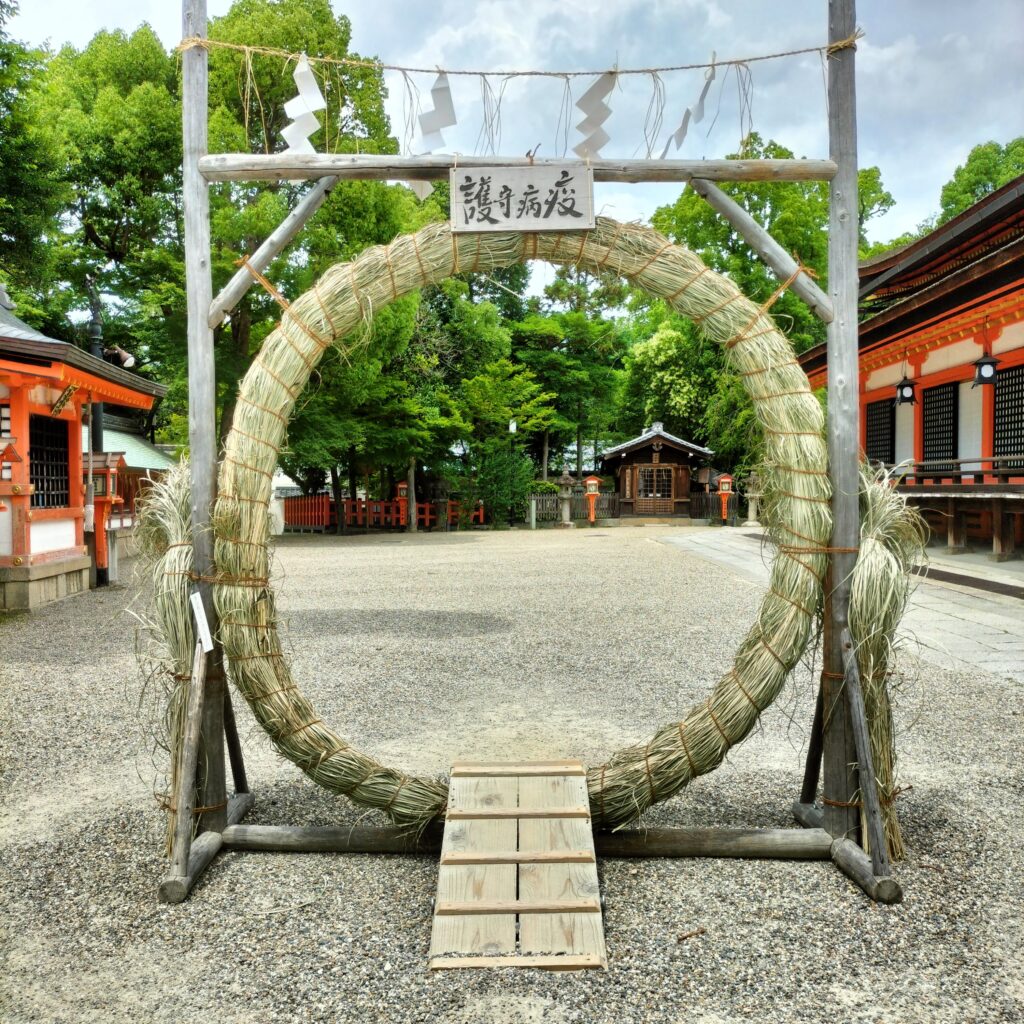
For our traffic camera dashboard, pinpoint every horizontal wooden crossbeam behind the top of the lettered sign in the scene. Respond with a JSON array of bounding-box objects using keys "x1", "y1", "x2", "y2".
[{"x1": 199, "y1": 153, "x2": 836, "y2": 182}]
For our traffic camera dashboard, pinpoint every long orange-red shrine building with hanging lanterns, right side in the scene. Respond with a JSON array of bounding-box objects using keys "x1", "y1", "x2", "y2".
[{"x1": 800, "y1": 176, "x2": 1024, "y2": 560}]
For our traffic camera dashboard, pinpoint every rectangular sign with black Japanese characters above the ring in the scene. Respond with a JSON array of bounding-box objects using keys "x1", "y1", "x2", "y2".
[{"x1": 449, "y1": 164, "x2": 594, "y2": 231}]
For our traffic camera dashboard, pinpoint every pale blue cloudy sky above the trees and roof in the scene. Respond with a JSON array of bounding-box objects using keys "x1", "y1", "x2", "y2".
[{"x1": 10, "y1": 0, "x2": 1024, "y2": 240}]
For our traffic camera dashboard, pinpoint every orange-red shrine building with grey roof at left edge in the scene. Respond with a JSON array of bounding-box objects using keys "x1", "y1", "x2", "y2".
[{"x1": 0, "y1": 288, "x2": 171, "y2": 610}]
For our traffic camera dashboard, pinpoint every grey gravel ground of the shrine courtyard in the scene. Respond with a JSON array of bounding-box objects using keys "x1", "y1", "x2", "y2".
[{"x1": 0, "y1": 527, "x2": 1024, "y2": 1024}]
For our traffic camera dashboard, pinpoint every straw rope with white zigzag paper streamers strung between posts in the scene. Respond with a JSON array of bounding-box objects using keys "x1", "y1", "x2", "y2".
[{"x1": 177, "y1": 30, "x2": 862, "y2": 164}]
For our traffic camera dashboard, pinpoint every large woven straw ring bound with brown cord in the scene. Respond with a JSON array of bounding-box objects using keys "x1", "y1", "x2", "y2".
[{"x1": 134, "y1": 218, "x2": 921, "y2": 847}]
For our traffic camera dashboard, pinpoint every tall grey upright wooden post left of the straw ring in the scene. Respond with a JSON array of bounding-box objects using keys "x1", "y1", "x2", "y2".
[{"x1": 181, "y1": 0, "x2": 227, "y2": 831}]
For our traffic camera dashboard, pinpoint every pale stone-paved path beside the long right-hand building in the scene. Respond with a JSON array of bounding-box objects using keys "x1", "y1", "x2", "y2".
[{"x1": 663, "y1": 527, "x2": 1024, "y2": 682}]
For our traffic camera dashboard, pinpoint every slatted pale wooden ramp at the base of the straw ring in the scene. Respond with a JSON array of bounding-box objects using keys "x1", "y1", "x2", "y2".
[{"x1": 430, "y1": 761, "x2": 607, "y2": 971}]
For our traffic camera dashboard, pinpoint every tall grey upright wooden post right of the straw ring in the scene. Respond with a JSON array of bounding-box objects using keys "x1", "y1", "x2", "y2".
[{"x1": 823, "y1": 0, "x2": 860, "y2": 840}]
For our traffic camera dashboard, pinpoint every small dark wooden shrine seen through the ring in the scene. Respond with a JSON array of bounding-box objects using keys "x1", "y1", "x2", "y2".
[{"x1": 601, "y1": 423, "x2": 714, "y2": 516}]
